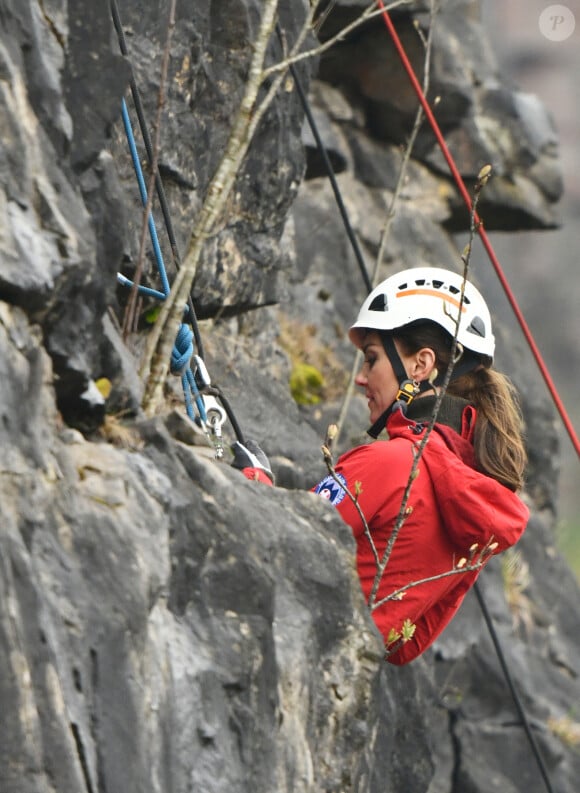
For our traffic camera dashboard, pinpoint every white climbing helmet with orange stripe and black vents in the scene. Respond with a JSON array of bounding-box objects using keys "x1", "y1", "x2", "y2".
[{"x1": 349, "y1": 267, "x2": 495, "y2": 358}]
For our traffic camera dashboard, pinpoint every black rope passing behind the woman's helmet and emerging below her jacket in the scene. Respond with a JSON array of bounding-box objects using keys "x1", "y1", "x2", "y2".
[{"x1": 286, "y1": 20, "x2": 554, "y2": 793}]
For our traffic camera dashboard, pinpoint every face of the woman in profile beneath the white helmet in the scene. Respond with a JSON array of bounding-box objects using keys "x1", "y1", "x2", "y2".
[{"x1": 355, "y1": 331, "x2": 407, "y2": 424}]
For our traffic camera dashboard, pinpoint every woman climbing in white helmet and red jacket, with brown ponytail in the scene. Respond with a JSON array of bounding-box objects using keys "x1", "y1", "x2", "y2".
[{"x1": 233, "y1": 267, "x2": 528, "y2": 664}]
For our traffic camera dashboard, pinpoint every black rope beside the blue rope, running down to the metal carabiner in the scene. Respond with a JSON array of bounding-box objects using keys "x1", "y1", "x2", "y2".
[{"x1": 110, "y1": 0, "x2": 244, "y2": 444}]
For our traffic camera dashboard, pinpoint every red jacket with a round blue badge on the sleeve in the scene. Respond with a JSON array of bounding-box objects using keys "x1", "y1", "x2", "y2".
[{"x1": 314, "y1": 407, "x2": 529, "y2": 664}]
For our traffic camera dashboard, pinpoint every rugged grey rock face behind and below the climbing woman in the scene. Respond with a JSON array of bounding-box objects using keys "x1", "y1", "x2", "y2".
[{"x1": 0, "y1": 0, "x2": 580, "y2": 793}]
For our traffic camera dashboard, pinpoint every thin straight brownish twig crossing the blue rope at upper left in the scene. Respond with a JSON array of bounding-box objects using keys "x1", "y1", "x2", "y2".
[{"x1": 123, "y1": 0, "x2": 177, "y2": 341}]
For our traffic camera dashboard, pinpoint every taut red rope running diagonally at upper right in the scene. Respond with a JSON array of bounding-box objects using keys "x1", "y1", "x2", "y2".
[{"x1": 377, "y1": 0, "x2": 580, "y2": 457}]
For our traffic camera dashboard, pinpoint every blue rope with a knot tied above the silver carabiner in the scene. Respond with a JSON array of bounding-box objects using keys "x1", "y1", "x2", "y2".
[{"x1": 117, "y1": 99, "x2": 207, "y2": 423}]
